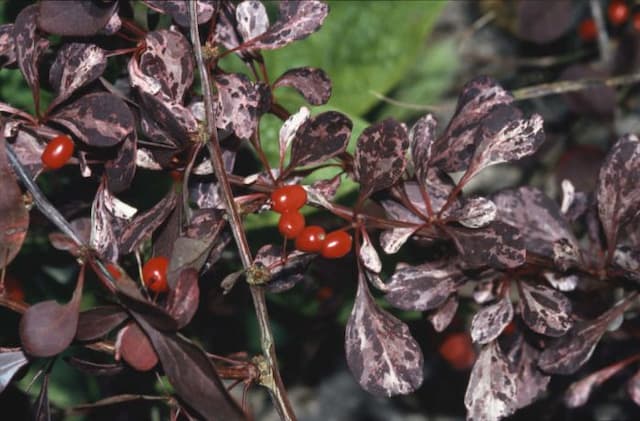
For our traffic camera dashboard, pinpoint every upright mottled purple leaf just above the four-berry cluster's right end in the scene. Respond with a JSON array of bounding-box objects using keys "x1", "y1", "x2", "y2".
[{"x1": 354, "y1": 118, "x2": 409, "y2": 198}]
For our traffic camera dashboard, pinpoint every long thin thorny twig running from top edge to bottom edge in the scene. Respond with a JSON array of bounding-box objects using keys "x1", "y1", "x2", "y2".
[{"x1": 189, "y1": 2, "x2": 296, "y2": 420}]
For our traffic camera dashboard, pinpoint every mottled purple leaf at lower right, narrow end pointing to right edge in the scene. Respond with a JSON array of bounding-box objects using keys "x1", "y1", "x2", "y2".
[{"x1": 538, "y1": 295, "x2": 635, "y2": 374}]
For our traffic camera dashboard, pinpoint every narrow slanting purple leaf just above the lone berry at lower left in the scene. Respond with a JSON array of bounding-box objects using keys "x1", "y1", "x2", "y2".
[{"x1": 117, "y1": 188, "x2": 177, "y2": 254}]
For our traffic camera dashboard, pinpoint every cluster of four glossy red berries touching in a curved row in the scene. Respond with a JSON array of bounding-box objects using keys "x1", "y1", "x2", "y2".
[{"x1": 271, "y1": 185, "x2": 352, "y2": 259}]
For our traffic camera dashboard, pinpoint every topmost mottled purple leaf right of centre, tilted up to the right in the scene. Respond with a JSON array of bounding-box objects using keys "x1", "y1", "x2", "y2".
[{"x1": 431, "y1": 76, "x2": 513, "y2": 172}]
